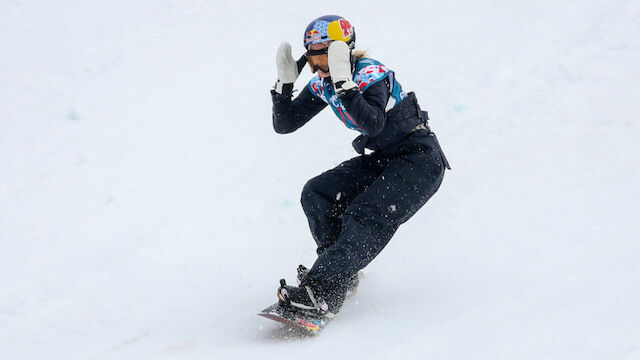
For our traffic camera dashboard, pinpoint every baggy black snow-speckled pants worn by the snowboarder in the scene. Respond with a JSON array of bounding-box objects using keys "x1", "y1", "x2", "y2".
[{"x1": 301, "y1": 130, "x2": 445, "y2": 289}]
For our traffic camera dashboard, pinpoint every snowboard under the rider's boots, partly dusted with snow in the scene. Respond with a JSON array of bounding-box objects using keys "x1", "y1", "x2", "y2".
[{"x1": 258, "y1": 302, "x2": 331, "y2": 335}]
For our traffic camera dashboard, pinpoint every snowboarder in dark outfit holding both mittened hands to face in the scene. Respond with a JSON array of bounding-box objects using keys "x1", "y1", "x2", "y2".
[{"x1": 271, "y1": 15, "x2": 450, "y2": 318}]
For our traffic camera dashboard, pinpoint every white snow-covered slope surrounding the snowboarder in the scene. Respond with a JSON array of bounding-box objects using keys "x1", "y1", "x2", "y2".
[{"x1": 0, "y1": 0, "x2": 640, "y2": 360}]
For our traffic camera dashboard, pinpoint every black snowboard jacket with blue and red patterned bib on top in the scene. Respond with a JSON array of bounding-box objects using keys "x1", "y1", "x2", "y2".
[{"x1": 271, "y1": 58, "x2": 448, "y2": 167}]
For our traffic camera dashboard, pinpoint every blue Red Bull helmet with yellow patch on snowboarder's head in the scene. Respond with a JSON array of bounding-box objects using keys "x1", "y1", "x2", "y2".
[{"x1": 304, "y1": 15, "x2": 356, "y2": 50}]
